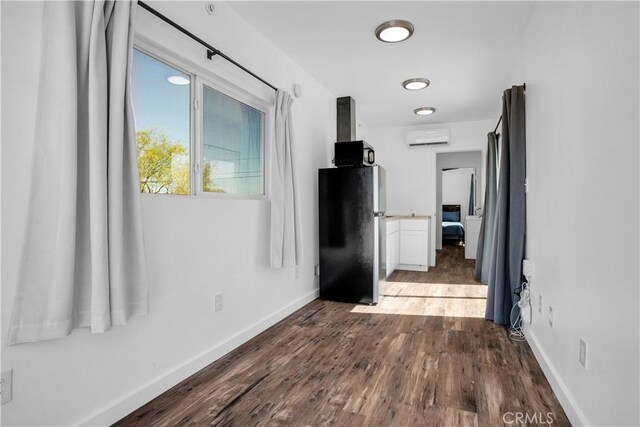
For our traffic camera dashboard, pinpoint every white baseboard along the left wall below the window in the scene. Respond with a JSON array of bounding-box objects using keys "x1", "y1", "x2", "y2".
[{"x1": 74, "y1": 289, "x2": 319, "y2": 426}]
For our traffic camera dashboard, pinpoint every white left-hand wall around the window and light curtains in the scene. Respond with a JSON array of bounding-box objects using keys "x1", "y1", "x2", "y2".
[{"x1": 1, "y1": 2, "x2": 335, "y2": 425}]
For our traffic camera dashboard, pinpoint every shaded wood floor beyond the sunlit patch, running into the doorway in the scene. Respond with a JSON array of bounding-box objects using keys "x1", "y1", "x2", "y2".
[{"x1": 387, "y1": 244, "x2": 481, "y2": 285}]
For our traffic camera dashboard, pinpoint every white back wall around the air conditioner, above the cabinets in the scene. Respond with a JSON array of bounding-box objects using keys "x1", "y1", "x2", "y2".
[{"x1": 358, "y1": 119, "x2": 492, "y2": 265}]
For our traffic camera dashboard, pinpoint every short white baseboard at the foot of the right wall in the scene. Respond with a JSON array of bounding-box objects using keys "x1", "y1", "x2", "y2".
[{"x1": 524, "y1": 328, "x2": 591, "y2": 426}]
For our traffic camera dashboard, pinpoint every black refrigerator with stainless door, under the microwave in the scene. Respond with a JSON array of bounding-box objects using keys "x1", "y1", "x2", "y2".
[{"x1": 318, "y1": 165, "x2": 387, "y2": 304}]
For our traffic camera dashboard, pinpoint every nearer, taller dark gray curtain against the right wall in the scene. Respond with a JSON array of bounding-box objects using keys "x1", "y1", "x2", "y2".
[{"x1": 485, "y1": 86, "x2": 526, "y2": 325}]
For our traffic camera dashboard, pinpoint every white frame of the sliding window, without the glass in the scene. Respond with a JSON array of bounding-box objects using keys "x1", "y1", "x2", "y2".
[{"x1": 133, "y1": 35, "x2": 275, "y2": 200}]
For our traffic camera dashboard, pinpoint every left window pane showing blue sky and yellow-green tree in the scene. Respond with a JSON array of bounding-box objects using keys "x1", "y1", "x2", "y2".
[{"x1": 133, "y1": 50, "x2": 192, "y2": 195}]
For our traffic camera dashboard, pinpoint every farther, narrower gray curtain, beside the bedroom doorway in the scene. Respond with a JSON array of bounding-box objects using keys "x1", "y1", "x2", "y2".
[{"x1": 475, "y1": 132, "x2": 498, "y2": 284}]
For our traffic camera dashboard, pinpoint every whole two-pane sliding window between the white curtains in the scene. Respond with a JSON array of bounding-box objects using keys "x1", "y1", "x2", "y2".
[{"x1": 133, "y1": 45, "x2": 267, "y2": 197}]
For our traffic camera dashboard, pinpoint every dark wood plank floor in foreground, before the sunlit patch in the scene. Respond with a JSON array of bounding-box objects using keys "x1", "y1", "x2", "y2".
[{"x1": 116, "y1": 296, "x2": 570, "y2": 426}]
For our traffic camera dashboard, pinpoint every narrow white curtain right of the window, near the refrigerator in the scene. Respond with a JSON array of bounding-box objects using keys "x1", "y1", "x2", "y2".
[{"x1": 270, "y1": 90, "x2": 302, "y2": 268}]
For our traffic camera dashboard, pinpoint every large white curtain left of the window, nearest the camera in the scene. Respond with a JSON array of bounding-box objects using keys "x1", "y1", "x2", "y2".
[{"x1": 9, "y1": 1, "x2": 147, "y2": 344}]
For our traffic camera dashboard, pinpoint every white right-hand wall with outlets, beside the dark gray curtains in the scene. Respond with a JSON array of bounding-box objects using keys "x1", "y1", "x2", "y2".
[{"x1": 512, "y1": 2, "x2": 640, "y2": 426}]
